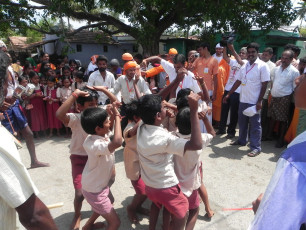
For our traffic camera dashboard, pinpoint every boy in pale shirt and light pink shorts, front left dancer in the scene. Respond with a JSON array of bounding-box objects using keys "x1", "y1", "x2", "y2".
[{"x1": 81, "y1": 103, "x2": 122, "y2": 230}]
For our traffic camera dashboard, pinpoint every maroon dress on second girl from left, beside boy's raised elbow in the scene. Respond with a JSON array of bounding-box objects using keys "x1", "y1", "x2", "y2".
[{"x1": 45, "y1": 87, "x2": 62, "y2": 129}]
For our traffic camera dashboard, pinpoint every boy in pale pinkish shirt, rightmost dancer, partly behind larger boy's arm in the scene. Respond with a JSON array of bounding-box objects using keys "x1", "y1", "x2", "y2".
[{"x1": 173, "y1": 107, "x2": 216, "y2": 230}]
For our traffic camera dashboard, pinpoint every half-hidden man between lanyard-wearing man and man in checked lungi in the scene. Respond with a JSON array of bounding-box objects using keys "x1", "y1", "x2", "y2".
[{"x1": 261, "y1": 47, "x2": 275, "y2": 141}]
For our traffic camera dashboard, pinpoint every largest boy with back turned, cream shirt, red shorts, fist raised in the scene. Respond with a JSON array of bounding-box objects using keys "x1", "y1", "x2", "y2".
[{"x1": 137, "y1": 93, "x2": 202, "y2": 230}]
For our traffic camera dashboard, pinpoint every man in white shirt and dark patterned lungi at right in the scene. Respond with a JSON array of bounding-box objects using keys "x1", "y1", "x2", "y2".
[{"x1": 267, "y1": 50, "x2": 300, "y2": 148}]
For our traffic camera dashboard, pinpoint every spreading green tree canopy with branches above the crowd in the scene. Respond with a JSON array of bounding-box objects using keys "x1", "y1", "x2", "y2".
[{"x1": 0, "y1": 0, "x2": 296, "y2": 54}]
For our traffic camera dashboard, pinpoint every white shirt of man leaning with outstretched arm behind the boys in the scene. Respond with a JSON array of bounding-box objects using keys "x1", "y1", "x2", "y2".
[{"x1": 161, "y1": 60, "x2": 202, "y2": 95}]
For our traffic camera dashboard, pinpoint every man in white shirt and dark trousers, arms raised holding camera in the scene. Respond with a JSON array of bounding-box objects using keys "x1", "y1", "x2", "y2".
[{"x1": 217, "y1": 44, "x2": 247, "y2": 138}]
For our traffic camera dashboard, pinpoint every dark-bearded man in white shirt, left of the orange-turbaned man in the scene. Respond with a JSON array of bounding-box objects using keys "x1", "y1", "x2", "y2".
[{"x1": 87, "y1": 55, "x2": 115, "y2": 105}]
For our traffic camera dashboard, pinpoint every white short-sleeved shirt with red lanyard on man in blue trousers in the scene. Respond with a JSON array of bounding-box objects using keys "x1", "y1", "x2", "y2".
[{"x1": 237, "y1": 58, "x2": 270, "y2": 105}]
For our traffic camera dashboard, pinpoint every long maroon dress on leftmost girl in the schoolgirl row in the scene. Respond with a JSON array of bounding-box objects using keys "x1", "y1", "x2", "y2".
[{"x1": 30, "y1": 85, "x2": 48, "y2": 132}]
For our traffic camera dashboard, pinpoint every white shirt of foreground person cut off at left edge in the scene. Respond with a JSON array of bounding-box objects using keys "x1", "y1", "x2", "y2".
[{"x1": 0, "y1": 123, "x2": 38, "y2": 229}]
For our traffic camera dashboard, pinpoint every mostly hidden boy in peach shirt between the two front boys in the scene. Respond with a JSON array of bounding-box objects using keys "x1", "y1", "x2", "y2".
[{"x1": 123, "y1": 100, "x2": 149, "y2": 223}]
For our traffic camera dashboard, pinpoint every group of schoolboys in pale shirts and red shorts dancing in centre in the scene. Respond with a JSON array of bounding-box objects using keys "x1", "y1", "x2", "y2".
[{"x1": 50, "y1": 62, "x2": 215, "y2": 230}]
